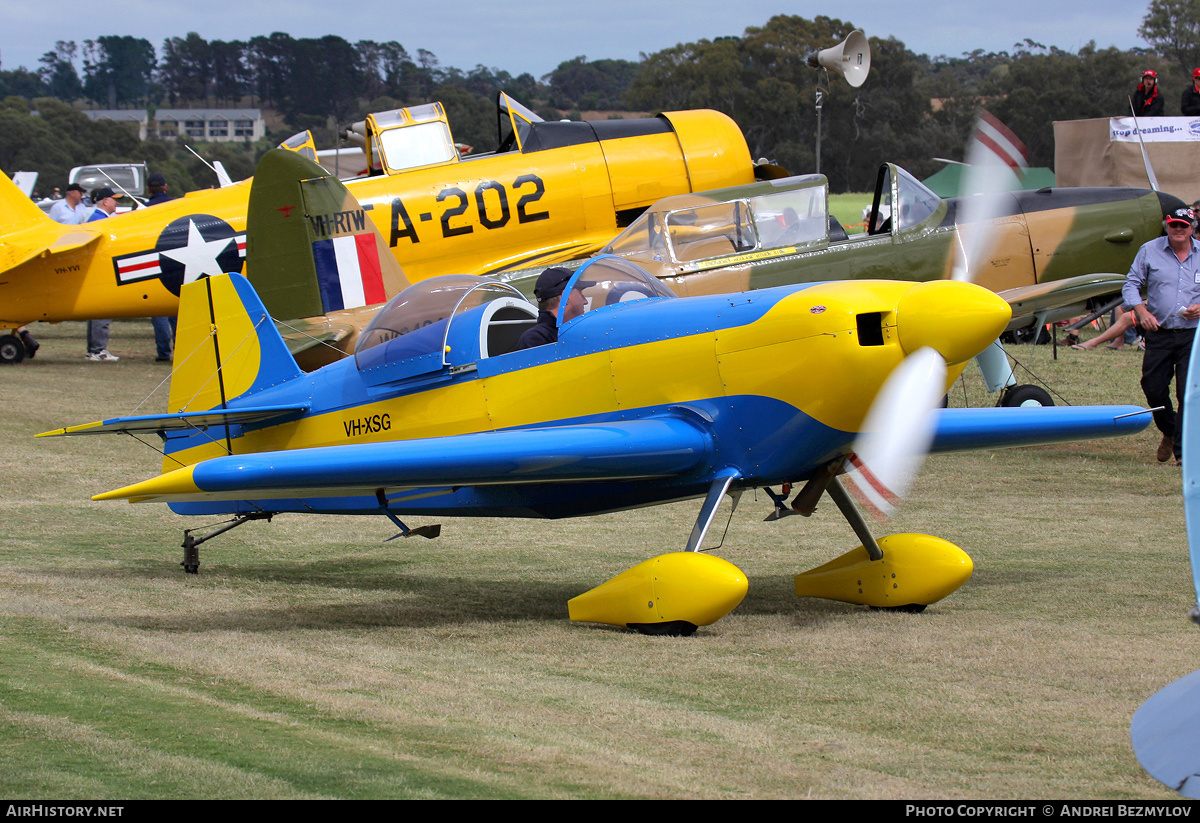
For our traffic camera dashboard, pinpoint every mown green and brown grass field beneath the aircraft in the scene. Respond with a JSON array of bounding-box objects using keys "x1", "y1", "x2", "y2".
[{"x1": 0, "y1": 322, "x2": 1200, "y2": 799}]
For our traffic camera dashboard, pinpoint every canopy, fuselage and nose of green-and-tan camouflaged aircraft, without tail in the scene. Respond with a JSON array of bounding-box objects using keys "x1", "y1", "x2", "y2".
[{"x1": 499, "y1": 163, "x2": 1186, "y2": 406}]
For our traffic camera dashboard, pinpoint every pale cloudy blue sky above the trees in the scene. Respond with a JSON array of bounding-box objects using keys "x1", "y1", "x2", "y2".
[{"x1": 0, "y1": 0, "x2": 1148, "y2": 77}]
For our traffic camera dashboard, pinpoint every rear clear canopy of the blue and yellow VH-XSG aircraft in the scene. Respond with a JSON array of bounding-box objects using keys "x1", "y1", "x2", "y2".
[{"x1": 354, "y1": 275, "x2": 523, "y2": 373}]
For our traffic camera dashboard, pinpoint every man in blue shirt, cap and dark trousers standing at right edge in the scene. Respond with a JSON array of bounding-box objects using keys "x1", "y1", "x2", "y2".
[{"x1": 1121, "y1": 208, "x2": 1200, "y2": 464}]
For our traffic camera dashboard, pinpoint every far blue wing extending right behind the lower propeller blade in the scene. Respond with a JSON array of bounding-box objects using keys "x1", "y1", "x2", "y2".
[{"x1": 931, "y1": 406, "x2": 1151, "y2": 451}]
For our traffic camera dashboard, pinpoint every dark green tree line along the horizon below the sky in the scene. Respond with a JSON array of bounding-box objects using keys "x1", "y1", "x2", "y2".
[{"x1": 0, "y1": 0, "x2": 1200, "y2": 191}]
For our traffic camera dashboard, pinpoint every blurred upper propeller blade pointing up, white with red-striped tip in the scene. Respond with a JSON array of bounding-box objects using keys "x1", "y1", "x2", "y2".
[{"x1": 950, "y1": 110, "x2": 1030, "y2": 282}]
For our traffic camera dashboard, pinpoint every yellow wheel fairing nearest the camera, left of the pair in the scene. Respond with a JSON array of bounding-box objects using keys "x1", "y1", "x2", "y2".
[{"x1": 566, "y1": 552, "x2": 748, "y2": 626}]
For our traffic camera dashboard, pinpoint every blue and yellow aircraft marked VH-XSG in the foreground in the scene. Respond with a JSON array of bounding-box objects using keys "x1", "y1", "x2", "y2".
[{"x1": 46, "y1": 256, "x2": 1150, "y2": 633}]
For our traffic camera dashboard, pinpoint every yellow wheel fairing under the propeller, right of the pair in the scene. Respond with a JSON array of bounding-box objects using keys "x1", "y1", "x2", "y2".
[{"x1": 796, "y1": 534, "x2": 974, "y2": 608}]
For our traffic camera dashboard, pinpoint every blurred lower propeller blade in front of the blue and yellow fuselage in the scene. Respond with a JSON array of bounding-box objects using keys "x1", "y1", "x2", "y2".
[{"x1": 846, "y1": 348, "x2": 946, "y2": 521}]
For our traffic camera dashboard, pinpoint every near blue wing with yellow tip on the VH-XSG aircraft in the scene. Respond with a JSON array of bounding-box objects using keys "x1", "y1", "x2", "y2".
[{"x1": 94, "y1": 417, "x2": 712, "y2": 503}]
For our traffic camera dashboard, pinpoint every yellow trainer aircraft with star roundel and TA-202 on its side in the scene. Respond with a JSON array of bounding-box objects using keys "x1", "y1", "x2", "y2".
[{"x1": 0, "y1": 92, "x2": 755, "y2": 362}]
